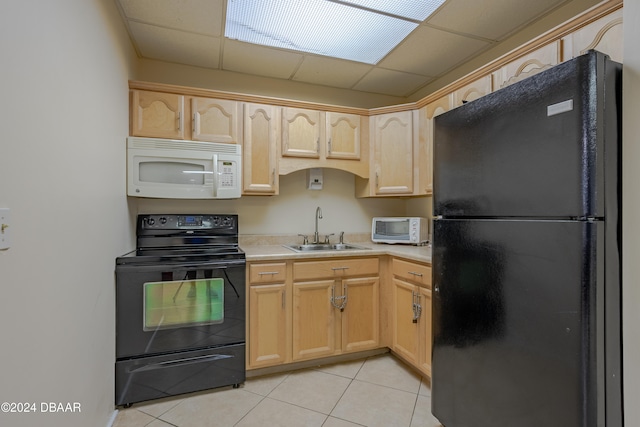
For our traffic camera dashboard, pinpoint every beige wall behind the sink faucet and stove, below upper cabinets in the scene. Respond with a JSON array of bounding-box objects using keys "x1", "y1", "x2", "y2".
[{"x1": 136, "y1": 169, "x2": 418, "y2": 239}]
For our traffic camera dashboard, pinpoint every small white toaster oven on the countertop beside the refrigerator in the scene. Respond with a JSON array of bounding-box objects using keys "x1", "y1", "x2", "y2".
[{"x1": 371, "y1": 217, "x2": 429, "y2": 245}]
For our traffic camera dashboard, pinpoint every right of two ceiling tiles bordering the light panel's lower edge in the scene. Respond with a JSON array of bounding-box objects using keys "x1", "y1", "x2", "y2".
[{"x1": 293, "y1": 55, "x2": 372, "y2": 88}]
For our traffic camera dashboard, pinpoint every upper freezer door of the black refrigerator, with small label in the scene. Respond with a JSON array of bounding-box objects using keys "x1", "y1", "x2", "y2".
[{"x1": 433, "y1": 52, "x2": 618, "y2": 218}]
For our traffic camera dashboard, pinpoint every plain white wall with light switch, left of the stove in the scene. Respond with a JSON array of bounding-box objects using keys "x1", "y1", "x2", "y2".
[{"x1": 0, "y1": 0, "x2": 134, "y2": 427}]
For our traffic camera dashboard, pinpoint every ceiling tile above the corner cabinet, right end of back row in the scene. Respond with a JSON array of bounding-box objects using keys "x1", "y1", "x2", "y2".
[{"x1": 354, "y1": 68, "x2": 431, "y2": 96}]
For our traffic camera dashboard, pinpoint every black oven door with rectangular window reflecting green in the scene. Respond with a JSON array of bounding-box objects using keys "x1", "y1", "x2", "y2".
[{"x1": 116, "y1": 260, "x2": 245, "y2": 359}]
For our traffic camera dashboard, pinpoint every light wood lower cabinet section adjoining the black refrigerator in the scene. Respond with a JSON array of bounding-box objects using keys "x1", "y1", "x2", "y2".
[{"x1": 391, "y1": 259, "x2": 432, "y2": 377}]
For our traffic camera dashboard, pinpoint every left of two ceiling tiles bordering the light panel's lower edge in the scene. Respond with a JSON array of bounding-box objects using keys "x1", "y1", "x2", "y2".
[{"x1": 222, "y1": 40, "x2": 302, "y2": 79}]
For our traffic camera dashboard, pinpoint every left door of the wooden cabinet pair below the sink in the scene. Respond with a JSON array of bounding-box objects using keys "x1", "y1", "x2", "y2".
[{"x1": 292, "y1": 280, "x2": 336, "y2": 360}]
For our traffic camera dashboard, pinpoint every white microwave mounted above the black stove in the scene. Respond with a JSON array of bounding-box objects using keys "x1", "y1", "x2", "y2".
[{"x1": 127, "y1": 137, "x2": 242, "y2": 199}]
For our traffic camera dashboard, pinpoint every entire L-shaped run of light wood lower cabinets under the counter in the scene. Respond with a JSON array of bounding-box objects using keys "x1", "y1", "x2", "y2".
[{"x1": 247, "y1": 257, "x2": 431, "y2": 376}]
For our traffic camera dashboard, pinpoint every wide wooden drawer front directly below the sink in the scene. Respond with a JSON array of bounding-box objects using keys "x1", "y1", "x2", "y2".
[{"x1": 293, "y1": 258, "x2": 378, "y2": 280}]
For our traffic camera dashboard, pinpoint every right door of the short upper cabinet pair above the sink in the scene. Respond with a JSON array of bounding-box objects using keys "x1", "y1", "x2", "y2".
[{"x1": 326, "y1": 112, "x2": 360, "y2": 160}]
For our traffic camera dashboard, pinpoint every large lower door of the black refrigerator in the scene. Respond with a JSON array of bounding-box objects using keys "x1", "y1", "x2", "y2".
[{"x1": 432, "y1": 219, "x2": 605, "y2": 427}]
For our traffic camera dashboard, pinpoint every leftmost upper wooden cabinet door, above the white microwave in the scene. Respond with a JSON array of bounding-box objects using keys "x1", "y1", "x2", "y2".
[{"x1": 131, "y1": 90, "x2": 184, "y2": 139}]
